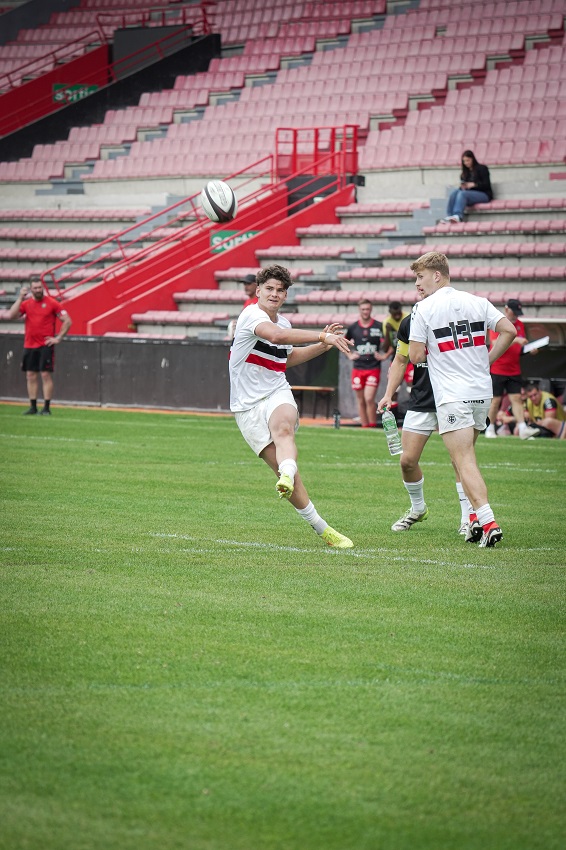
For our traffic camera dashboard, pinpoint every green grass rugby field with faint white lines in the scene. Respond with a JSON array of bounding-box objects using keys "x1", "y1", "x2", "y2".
[{"x1": 0, "y1": 405, "x2": 566, "y2": 850}]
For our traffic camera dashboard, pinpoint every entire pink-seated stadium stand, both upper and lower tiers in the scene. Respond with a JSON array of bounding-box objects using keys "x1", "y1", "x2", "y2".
[{"x1": 0, "y1": 0, "x2": 566, "y2": 344}]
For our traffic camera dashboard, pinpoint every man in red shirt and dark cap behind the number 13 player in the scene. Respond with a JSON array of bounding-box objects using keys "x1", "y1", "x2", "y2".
[{"x1": 485, "y1": 298, "x2": 538, "y2": 440}]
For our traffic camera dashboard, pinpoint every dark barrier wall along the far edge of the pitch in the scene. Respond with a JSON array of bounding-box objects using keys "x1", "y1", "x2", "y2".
[{"x1": 0, "y1": 333, "x2": 338, "y2": 414}]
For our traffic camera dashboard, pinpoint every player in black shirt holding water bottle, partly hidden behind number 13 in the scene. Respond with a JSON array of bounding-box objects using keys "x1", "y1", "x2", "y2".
[{"x1": 377, "y1": 304, "x2": 472, "y2": 536}]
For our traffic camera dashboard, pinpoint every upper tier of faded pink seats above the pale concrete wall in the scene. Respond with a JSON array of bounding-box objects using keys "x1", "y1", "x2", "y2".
[{"x1": 0, "y1": 0, "x2": 566, "y2": 181}]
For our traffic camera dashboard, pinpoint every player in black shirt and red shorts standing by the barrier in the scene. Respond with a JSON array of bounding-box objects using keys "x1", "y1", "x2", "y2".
[{"x1": 344, "y1": 298, "x2": 386, "y2": 428}]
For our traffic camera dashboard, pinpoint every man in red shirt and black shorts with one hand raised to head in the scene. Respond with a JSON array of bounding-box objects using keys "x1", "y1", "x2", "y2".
[{"x1": 9, "y1": 280, "x2": 71, "y2": 416}]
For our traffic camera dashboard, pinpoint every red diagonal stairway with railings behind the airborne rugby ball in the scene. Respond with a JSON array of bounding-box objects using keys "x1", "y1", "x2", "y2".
[{"x1": 41, "y1": 127, "x2": 355, "y2": 333}]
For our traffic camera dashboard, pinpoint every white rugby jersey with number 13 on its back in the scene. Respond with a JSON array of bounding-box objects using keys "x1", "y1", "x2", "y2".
[{"x1": 409, "y1": 286, "x2": 505, "y2": 405}]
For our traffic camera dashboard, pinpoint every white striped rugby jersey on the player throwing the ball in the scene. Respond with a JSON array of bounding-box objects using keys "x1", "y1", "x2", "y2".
[{"x1": 230, "y1": 304, "x2": 293, "y2": 413}]
